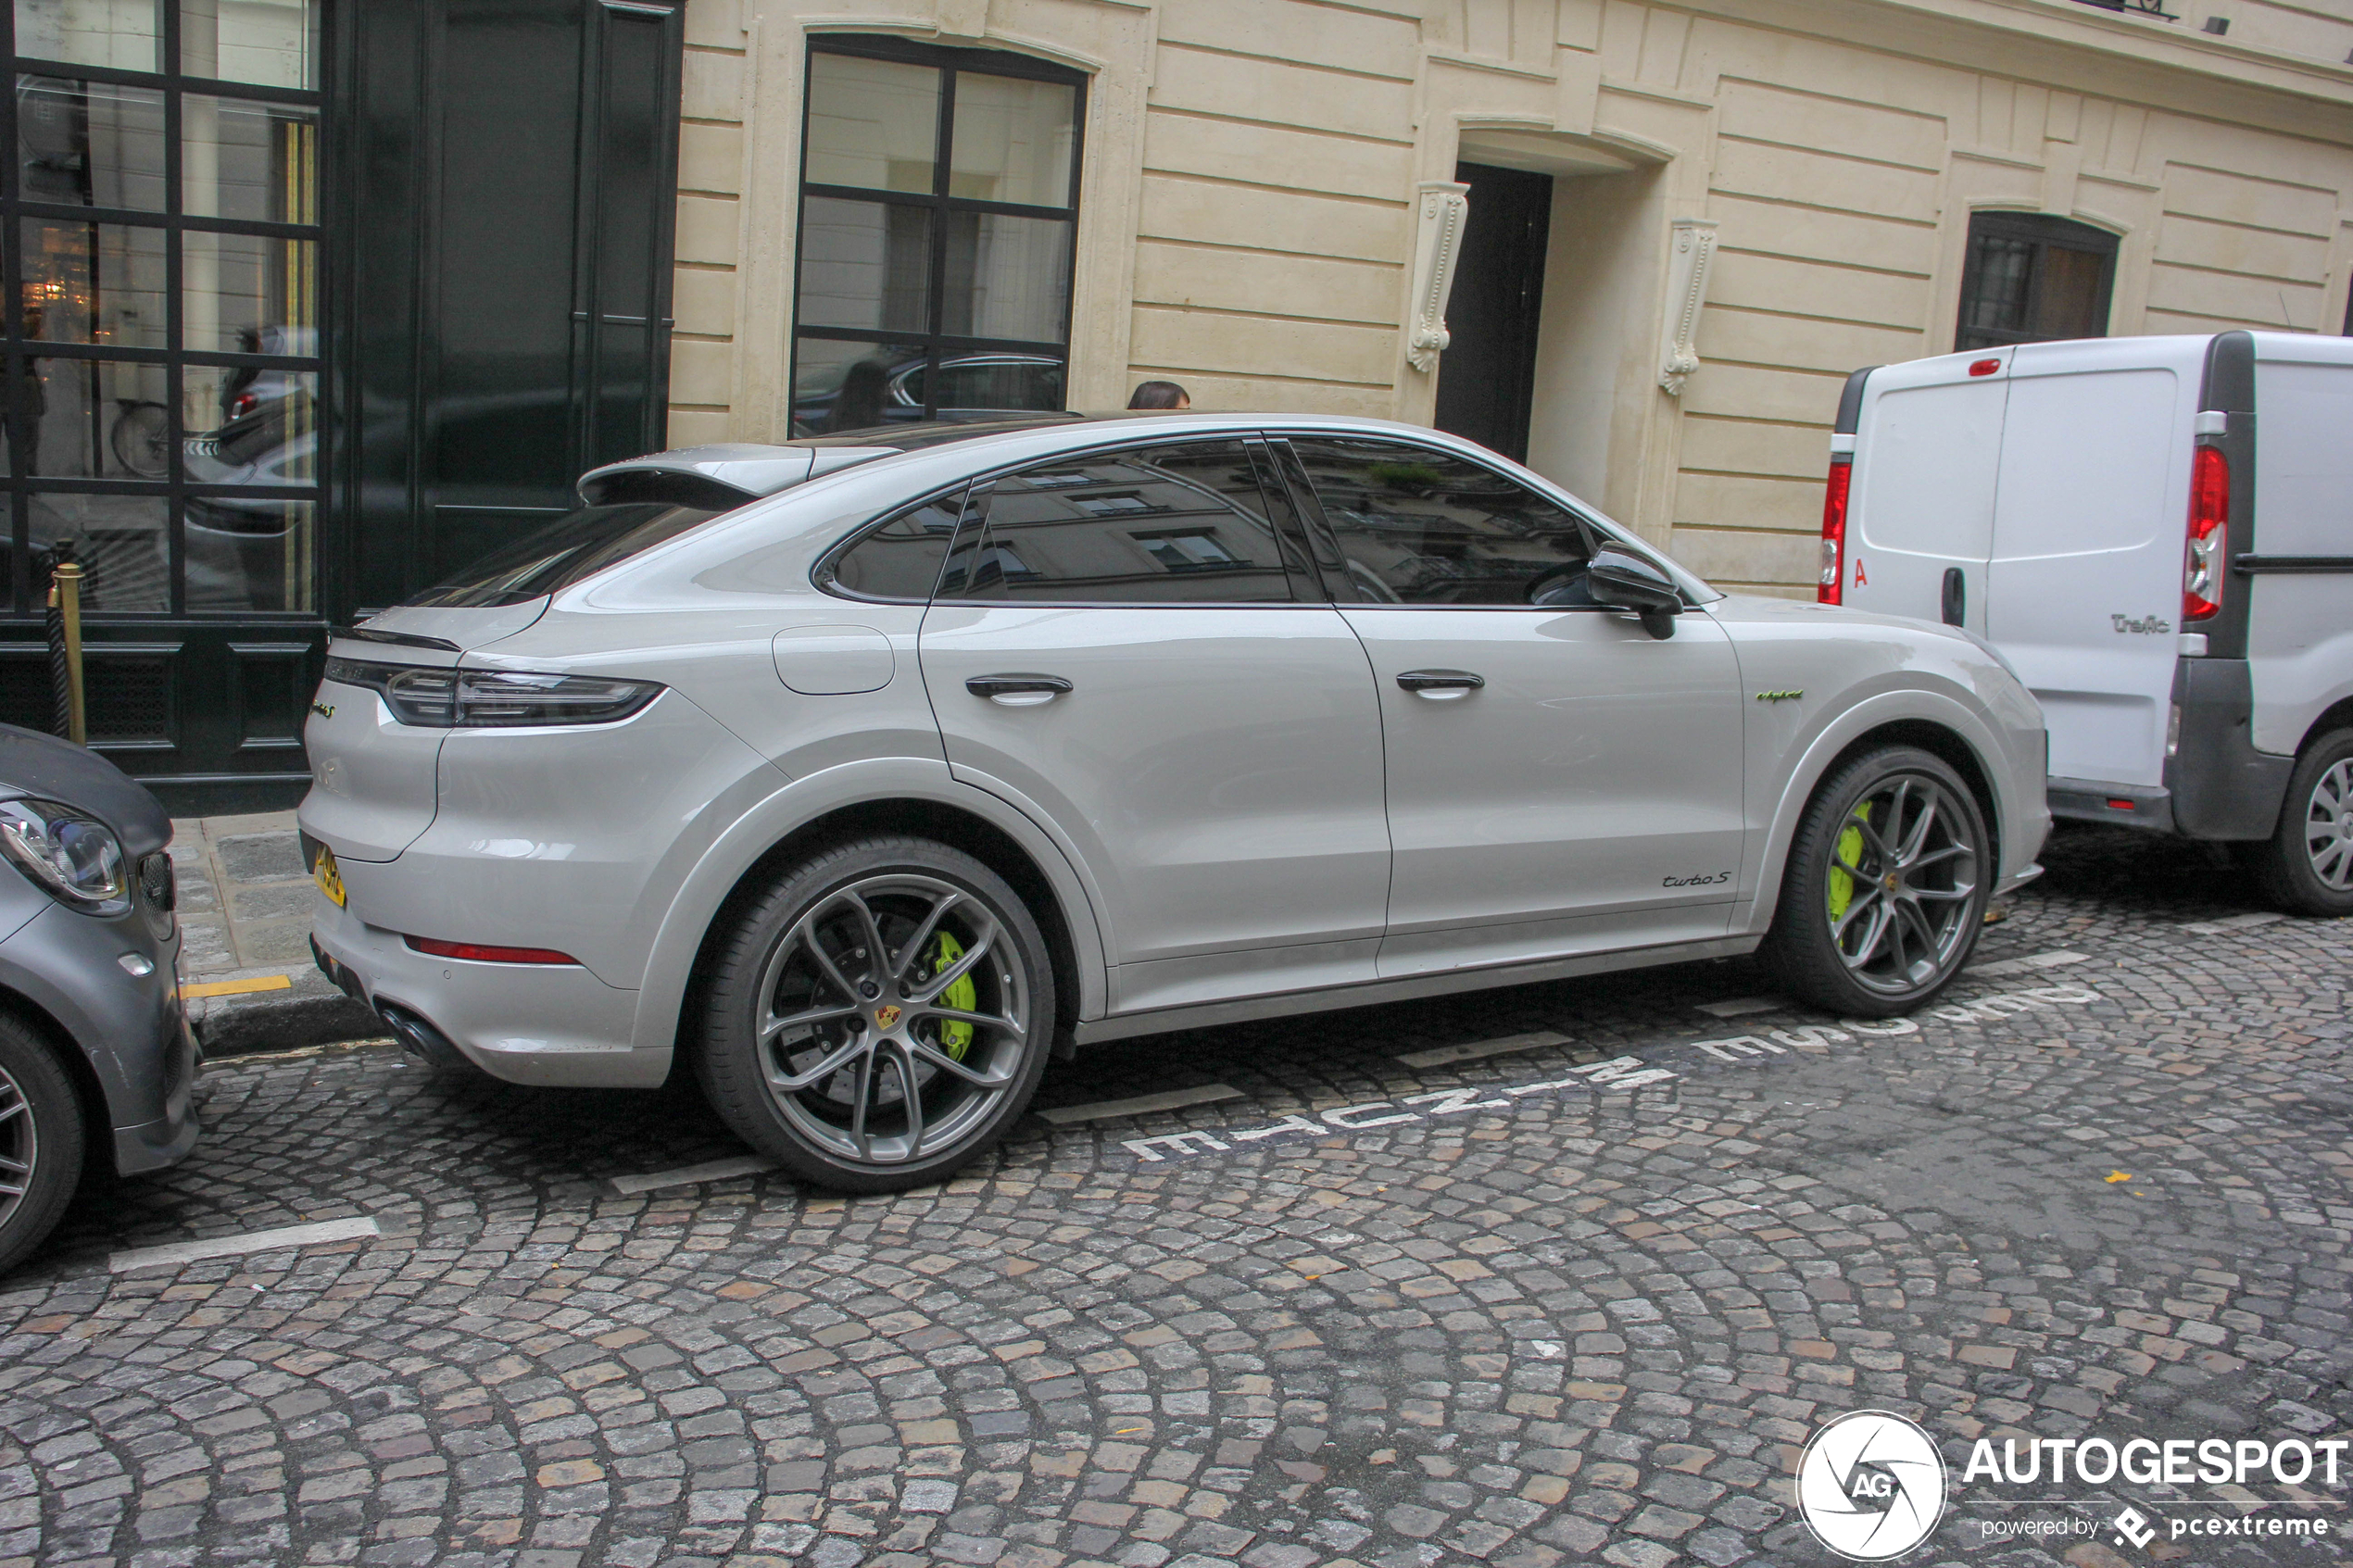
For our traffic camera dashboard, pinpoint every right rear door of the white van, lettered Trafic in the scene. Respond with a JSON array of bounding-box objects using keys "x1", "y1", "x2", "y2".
[{"x1": 1986, "y1": 339, "x2": 2208, "y2": 790}]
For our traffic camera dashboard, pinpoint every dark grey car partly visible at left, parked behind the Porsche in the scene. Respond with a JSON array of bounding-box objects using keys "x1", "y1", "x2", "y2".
[{"x1": 0, "y1": 724, "x2": 197, "y2": 1272}]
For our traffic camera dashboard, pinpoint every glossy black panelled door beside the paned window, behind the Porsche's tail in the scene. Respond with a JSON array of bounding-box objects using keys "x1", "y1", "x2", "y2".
[{"x1": 344, "y1": 0, "x2": 680, "y2": 613}]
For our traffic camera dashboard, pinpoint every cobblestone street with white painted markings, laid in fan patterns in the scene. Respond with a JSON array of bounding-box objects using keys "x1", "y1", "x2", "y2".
[{"x1": 0, "y1": 833, "x2": 2353, "y2": 1568}]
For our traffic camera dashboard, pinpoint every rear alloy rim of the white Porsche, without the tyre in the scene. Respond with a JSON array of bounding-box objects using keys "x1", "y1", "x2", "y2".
[{"x1": 755, "y1": 872, "x2": 1031, "y2": 1169}]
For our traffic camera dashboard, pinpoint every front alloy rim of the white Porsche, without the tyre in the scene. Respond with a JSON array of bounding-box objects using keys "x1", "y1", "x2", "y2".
[{"x1": 1826, "y1": 773, "x2": 1979, "y2": 997}]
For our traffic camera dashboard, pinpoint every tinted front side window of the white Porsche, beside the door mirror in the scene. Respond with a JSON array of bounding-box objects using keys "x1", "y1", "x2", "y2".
[{"x1": 1291, "y1": 437, "x2": 1593, "y2": 607}]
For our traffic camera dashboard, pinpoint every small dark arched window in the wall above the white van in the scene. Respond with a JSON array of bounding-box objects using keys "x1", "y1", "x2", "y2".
[{"x1": 1953, "y1": 211, "x2": 2115, "y2": 350}]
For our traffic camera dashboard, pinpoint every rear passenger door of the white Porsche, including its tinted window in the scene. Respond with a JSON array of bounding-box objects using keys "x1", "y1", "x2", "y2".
[{"x1": 920, "y1": 440, "x2": 1389, "y2": 1010}]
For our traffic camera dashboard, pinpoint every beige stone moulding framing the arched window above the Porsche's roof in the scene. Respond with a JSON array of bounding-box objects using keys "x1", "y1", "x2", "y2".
[{"x1": 727, "y1": 0, "x2": 1158, "y2": 442}]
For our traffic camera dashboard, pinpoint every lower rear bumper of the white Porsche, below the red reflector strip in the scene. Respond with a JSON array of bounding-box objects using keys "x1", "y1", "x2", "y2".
[{"x1": 310, "y1": 894, "x2": 671, "y2": 1088}]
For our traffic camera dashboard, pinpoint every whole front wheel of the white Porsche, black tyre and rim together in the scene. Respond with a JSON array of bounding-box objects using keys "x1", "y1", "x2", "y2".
[{"x1": 1765, "y1": 746, "x2": 1995, "y2": 1018}]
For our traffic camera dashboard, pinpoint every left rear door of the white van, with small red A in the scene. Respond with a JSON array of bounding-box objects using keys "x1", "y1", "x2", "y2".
[{"x1": 1840, "y1": 348, "x2": 2012, "y2": 633}]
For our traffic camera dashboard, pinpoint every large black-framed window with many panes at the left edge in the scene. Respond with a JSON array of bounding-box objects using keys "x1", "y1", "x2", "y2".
[{"x1": 0, "y1": 0, "x2": 325, "y2": 616}]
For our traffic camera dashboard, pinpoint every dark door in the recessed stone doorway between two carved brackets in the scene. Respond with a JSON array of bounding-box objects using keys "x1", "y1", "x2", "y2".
[{"x1": 1433, "y1": 162, "x2": 1553, "y2": 463}]
